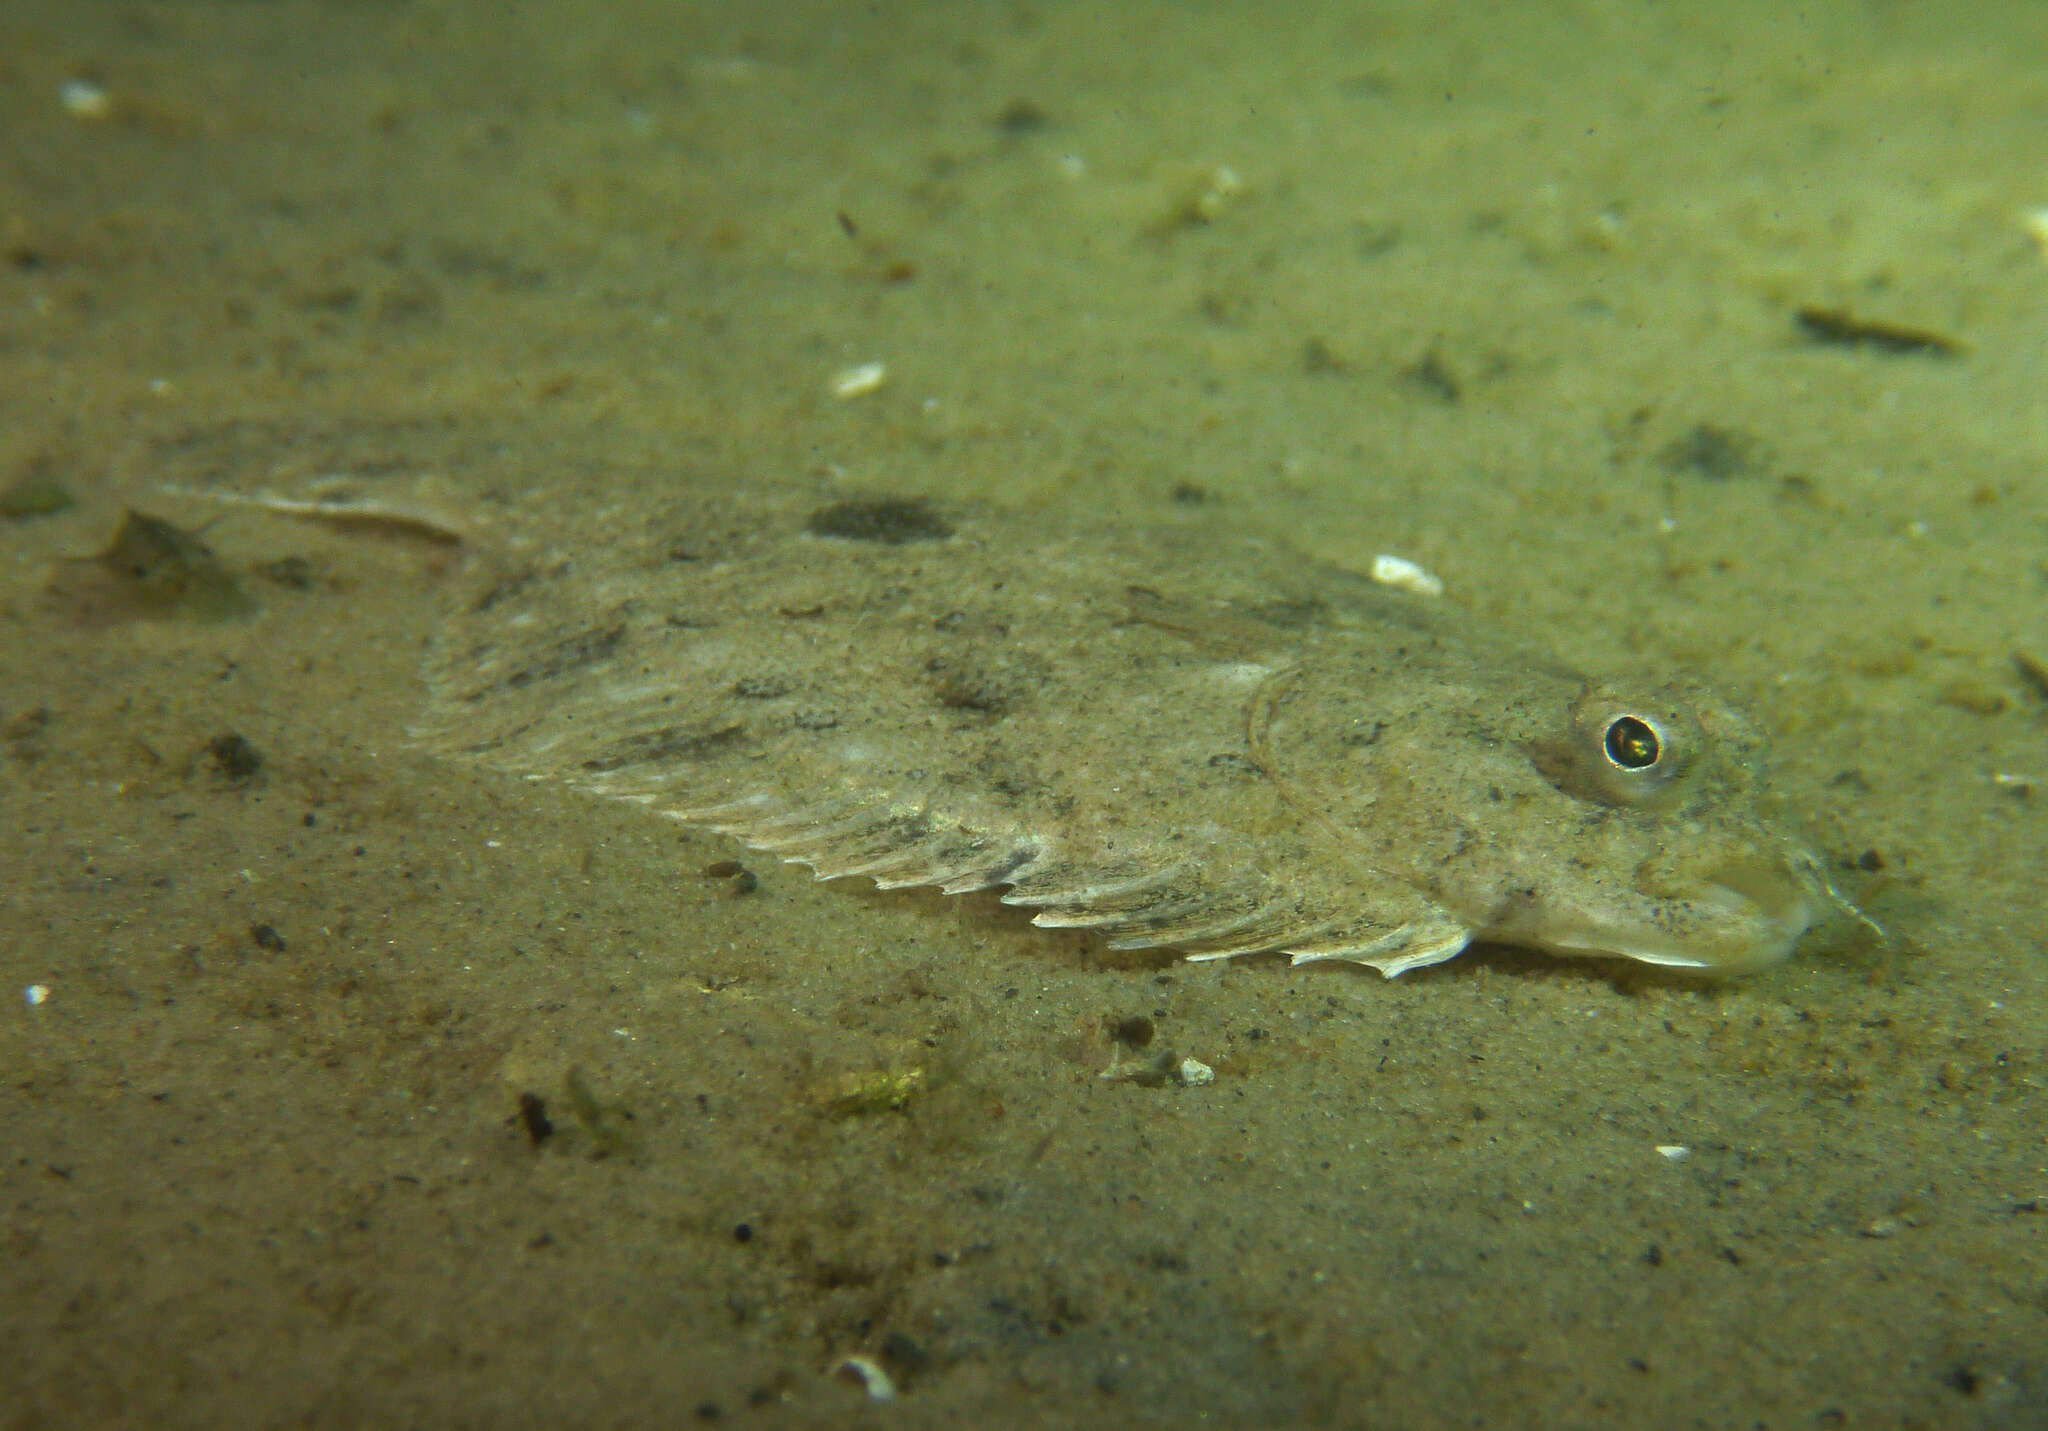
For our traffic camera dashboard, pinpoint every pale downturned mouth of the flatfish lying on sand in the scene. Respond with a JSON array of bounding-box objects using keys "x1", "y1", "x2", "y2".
[{"x1": 1524, "y1": 850, "x2": 1845, "y2": 977}]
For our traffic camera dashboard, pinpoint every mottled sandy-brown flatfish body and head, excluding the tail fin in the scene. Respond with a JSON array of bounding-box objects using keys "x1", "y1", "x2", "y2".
[{"x1": 418, "y1": 479, "x2": 1833, "y2": 977}]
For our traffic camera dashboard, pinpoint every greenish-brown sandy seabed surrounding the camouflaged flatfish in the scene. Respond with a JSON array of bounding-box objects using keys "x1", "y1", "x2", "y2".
[{"x1": 0, "y1": 0, "x2": 2048, "y2": 1431}]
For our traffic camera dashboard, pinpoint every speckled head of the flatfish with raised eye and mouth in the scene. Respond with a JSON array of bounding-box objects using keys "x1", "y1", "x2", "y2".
[{"x1": 1294, "y1": 669, "x2": 1860, "y2": 977}]
